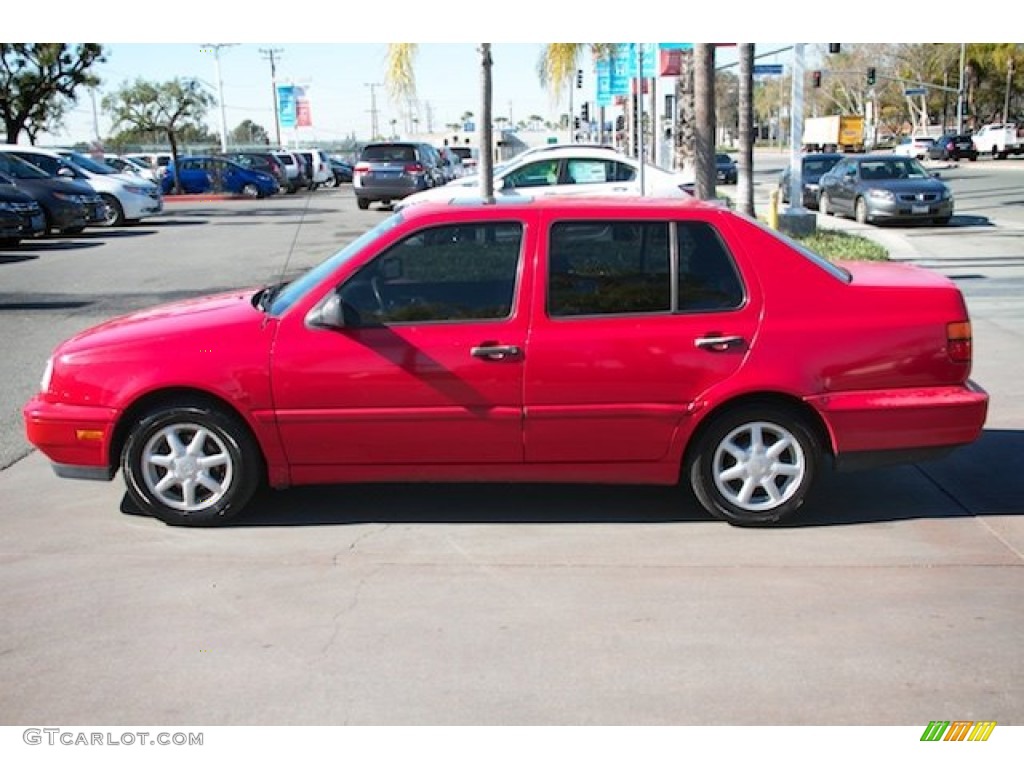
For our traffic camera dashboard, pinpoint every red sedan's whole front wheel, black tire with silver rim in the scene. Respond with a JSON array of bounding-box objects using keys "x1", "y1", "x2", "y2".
[{"x1": 121, "y1": 403, "x2": 264, "y2": 526}]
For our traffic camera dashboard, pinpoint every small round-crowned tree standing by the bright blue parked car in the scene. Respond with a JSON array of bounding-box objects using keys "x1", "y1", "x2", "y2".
[{"x1": 103, "y1": 78, "x2": 214, "y2": 193}]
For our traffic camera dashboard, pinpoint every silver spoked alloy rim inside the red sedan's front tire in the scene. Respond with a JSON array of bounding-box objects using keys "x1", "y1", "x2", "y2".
[{"x1": 141, "y1": 423, "x2": 234, "y2": 512}]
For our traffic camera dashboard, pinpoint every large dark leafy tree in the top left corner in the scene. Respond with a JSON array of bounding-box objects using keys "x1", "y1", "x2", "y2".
[{"x1": 0, "y1": 43, "x2": 106, "y2": 143}]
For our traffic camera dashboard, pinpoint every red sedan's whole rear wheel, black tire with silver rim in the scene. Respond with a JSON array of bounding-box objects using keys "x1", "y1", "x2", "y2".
[{"x1": 689, "y1": 406, "x2": 821, "y2": 525}]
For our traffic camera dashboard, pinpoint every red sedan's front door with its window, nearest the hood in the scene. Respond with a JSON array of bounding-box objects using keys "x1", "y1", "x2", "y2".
[{"x1": 272, "y1": 218, "x2": 531, "y2": 468}]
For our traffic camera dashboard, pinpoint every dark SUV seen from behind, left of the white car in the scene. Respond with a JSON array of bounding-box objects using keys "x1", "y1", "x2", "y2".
[{"x1": 352, "y1": 141, "x2": 444, "y2": 210}]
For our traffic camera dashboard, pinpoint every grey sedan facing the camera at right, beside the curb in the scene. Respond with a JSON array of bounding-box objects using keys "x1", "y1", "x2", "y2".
[{"x1": 818, "y1": 155, "x2": 953, "y2": 224}]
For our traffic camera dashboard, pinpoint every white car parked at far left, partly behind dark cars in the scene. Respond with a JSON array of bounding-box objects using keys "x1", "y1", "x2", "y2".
[{"x1": 0, "y1": 144, "x2": 164, "y2": 226}]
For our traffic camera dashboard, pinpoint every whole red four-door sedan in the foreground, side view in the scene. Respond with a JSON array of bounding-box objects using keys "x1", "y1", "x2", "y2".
[{"x1": 24, "y1": 198, "x2": 988, "y2": 525}]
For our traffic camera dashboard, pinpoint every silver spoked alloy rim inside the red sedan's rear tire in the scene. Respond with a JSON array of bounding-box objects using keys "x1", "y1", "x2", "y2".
[{"x1": 712, "y1": 421, "x2": 808, "y2": 512}]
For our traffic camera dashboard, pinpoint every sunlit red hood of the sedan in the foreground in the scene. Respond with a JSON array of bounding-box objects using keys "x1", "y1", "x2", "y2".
[{"x1": 58, "y1": 289, "x2": 265, "y2": 354}]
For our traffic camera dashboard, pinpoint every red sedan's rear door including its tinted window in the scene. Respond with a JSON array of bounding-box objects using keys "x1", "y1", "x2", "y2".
[{"x1": 523, "y1": 214, "x2": 761, "y2": 464}]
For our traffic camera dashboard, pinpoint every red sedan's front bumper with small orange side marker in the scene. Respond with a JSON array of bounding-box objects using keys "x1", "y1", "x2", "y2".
[{"x1": 23, "y1": 395, "x2": 119, "y2": 480}]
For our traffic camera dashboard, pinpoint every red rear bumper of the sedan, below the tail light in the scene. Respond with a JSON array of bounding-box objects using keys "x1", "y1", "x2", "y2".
[{"x1": 808, "y1": 381, "x2": 988, "y2": 463}]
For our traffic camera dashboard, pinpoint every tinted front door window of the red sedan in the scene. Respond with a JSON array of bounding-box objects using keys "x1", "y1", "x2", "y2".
[{"x1": 340, "y1": 222, "x2": 522, "y2": 326}]
